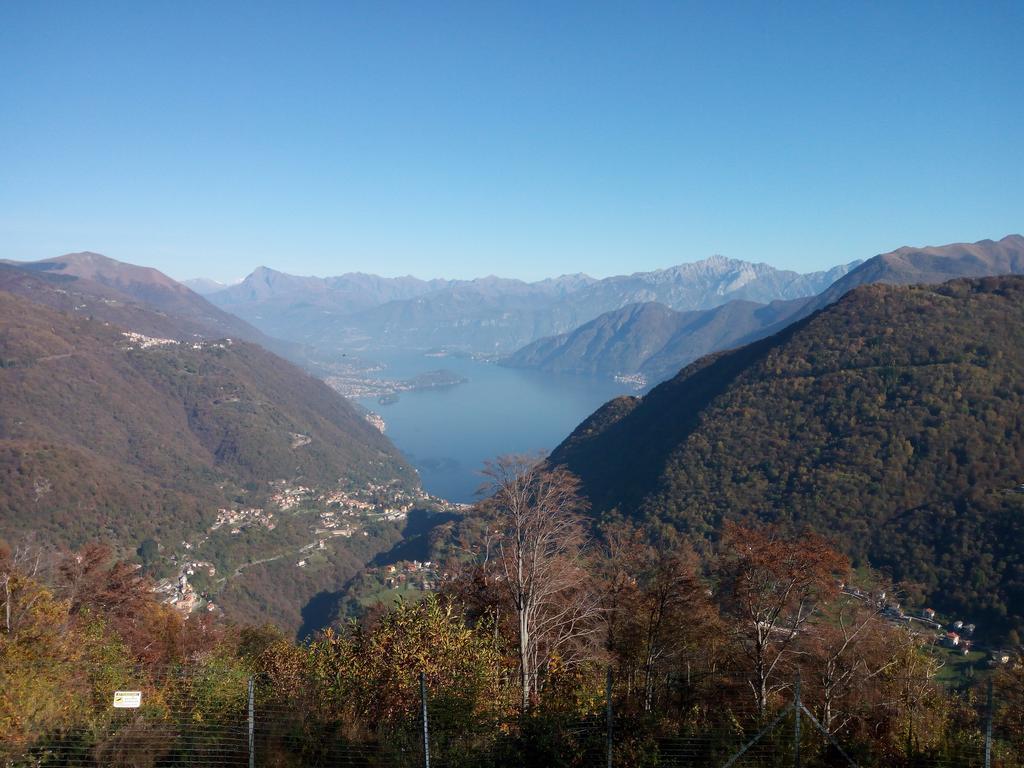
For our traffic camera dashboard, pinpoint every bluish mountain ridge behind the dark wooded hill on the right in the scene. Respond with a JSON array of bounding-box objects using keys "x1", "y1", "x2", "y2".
[{"x1": 503, "y1": 234, "x2": 1024, "y2": 382}]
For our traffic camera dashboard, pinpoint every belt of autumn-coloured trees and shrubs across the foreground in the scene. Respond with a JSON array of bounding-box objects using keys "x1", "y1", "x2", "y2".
[{"x1": 0, "y1": 528, "x2": 1024, "y2": 768}]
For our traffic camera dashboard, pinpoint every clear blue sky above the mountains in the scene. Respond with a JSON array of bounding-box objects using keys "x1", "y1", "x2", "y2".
[{"x1": 0, "y1": 0, "x2": 1024, "y2": 280}]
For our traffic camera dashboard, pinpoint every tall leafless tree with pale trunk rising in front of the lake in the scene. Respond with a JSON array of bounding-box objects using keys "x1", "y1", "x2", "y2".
[{"x1": 477, "y1": 456, "x2": 599, "y2": 710}]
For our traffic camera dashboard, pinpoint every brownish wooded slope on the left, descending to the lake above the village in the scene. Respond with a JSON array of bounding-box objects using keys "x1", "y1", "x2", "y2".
[{"x1": 0, "y1": 292, "x2": 417, "y2": 548}]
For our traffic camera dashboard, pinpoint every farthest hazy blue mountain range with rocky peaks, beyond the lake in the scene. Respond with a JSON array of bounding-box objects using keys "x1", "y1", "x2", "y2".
[{"x1": 199, "y1": 256, "x2": 855, "y2": 353}]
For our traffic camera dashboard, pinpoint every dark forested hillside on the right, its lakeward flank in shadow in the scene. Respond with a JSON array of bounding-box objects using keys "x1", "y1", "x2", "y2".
[{"x1": 551, "y1": 276, "x2": 1024, "y2": 630}]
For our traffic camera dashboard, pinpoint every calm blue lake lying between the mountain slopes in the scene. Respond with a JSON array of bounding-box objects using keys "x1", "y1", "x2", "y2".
[{"x1": 359, "y1": 353, "x2": 636, "y2": 502}]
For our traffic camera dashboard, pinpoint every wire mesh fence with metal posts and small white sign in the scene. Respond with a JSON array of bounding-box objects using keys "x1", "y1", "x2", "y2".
[{"x1": 0, "y1": 664, "x2": 1024, "y2": 768}]
